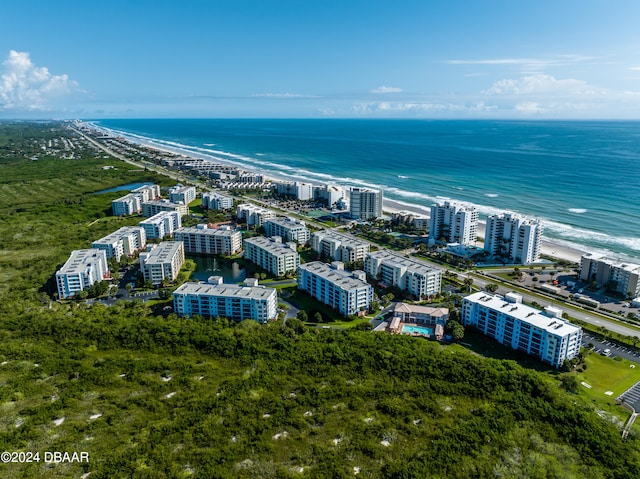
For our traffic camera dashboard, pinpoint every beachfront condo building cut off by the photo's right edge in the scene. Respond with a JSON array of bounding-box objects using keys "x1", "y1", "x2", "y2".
[{"x1": 580, "y1": 253, "x2": 640, "y2": 298}]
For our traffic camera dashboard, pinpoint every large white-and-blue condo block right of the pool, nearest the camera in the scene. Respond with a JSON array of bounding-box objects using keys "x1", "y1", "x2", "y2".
[{"x1": 462, "y1": 291, "x2": 582, "y2": 368}]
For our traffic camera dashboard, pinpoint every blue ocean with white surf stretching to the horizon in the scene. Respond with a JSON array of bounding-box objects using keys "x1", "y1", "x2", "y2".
[{"x1": 94, "y1": 119, "x2": 640, "y2": 257}]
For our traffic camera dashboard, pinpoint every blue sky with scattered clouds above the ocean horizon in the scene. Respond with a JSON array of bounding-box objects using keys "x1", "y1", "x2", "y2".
[{"x1": 0, "y1": 0, "x2": 640, "y2": 119}]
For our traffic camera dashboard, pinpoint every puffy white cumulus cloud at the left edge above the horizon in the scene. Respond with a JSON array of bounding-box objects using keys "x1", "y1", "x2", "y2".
[{"x1": 0, "y1": 50, "x2": 78, "y2": 111}]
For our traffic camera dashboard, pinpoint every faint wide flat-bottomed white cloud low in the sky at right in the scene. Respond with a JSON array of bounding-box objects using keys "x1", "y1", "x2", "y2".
[{"x1": 482, "y1": 74, "x2": 596, "y2": 95}]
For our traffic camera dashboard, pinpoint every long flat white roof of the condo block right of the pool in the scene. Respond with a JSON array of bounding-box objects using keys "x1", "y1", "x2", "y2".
[{"x1": 464, "y1": 291, "x2": 581, "y2": 336}]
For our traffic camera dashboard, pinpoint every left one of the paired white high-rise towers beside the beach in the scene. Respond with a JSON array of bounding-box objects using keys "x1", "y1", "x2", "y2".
[{"x1": 429, "y1": 201, "x2": 478, "y2": 245}]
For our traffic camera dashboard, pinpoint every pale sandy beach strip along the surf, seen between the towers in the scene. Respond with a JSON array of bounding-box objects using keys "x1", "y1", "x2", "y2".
[{"x1": 92, "y1": 122, "x2": 596, "y2": 264}]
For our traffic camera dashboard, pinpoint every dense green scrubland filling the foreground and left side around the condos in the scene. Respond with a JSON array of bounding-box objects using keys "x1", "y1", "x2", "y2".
[{"x1": 0, "y1": 124, "x2": 640, "y2": 479}]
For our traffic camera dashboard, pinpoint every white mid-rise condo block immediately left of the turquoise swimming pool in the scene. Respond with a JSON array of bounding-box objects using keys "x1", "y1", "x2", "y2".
[{"x1": 298, "y1": 261, "x2": 373, "y2": 316}]
